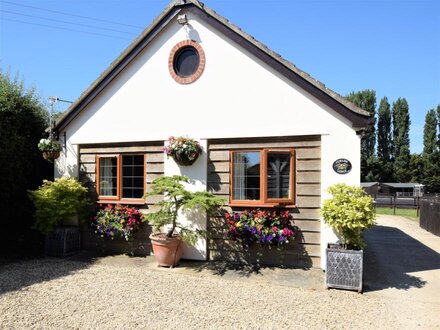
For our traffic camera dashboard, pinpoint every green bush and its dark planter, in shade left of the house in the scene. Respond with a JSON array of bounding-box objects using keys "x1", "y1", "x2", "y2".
[{"x1": 29, "y1": 178, "x2": 90, "y2": 257}]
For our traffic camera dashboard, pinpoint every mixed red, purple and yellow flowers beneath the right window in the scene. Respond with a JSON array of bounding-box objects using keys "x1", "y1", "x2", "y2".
[{"x1": 225, "y1": 209, "x2": 295, "y2": 248}]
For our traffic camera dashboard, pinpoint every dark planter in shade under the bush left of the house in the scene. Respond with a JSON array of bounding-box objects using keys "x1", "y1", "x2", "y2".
[{"x1": 44, "y1": 226, "x2": 81, "y2": 258}]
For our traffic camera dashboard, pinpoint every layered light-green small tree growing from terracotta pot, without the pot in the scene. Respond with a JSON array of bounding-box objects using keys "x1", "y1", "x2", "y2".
[{"x1": 144, "y1": 175, "x2": 225, "y2": 243}]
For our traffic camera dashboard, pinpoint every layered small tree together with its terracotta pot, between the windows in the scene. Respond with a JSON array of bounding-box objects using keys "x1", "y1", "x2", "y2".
[{"x1": 144, "y1": 175, "x2": 225, "y2": 267}]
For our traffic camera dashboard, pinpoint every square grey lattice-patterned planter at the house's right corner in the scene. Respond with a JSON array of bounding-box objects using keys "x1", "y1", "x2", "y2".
[{"x1": 325, "y1": 244, "x2": 364, "y2": 292}]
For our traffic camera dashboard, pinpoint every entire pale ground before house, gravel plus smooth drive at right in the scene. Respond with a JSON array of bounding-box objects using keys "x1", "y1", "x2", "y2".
[{"x1": 0, "y1": 216, "x2": 440, "y2": 329}]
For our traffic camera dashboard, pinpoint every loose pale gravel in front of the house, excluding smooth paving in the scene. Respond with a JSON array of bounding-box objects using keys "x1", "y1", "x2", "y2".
[{"x1": 0, "y1": 258, "x2": 405, "y2": 329}]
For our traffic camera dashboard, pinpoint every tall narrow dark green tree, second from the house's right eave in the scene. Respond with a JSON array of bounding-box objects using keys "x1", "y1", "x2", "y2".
[{"x1": 377, "y1": 96, "x2": 393, "y2": 182}]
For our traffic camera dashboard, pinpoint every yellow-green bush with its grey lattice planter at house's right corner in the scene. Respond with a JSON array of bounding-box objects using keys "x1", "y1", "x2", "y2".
[{"x1": 322, "y1": 184, "x2": 376, "y2": 292}]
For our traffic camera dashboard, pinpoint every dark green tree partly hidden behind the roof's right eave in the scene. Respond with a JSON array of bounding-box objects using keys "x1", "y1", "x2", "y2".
[{"x1": 346, "y1": 89, "x2": 376, "y2": 181}]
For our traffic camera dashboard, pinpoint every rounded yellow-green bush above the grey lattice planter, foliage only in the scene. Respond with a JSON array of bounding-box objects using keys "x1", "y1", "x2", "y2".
[{"x1": 321, "y1": 183, "x2": 376, "y2": 250}]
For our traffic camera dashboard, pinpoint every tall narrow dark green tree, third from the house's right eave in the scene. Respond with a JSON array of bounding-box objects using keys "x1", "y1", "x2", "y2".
[{"x1": 393, "y1": 98, "x2": 411, "y2": 182}]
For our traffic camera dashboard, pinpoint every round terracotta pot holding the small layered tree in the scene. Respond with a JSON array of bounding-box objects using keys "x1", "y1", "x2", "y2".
[{"x1": 150, "y1": 234, "x2": 183, "y2": 268}]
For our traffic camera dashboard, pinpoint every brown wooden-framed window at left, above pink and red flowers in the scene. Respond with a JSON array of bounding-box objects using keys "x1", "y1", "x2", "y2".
[{"x1": 96, "y1": 154, "x2": 146, "y2": 204}]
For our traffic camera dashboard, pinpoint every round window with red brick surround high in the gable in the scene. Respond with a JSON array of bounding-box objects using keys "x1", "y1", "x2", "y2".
[{"x1": 168, "y1": 40, "x2": 205, "y2": 84}]
